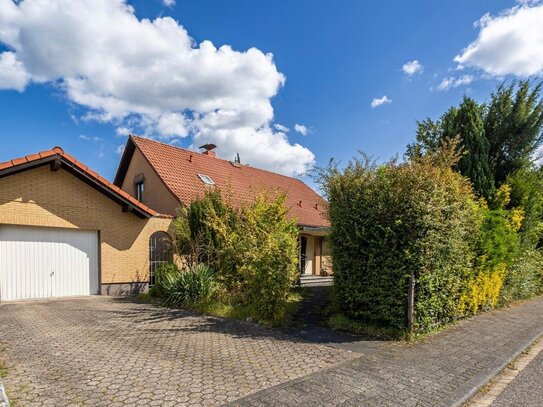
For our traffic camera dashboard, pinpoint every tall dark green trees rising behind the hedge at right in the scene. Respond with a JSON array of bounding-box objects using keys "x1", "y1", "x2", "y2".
[{"x1": 406, "y1": 81, "x2": 543, "y2": 199}]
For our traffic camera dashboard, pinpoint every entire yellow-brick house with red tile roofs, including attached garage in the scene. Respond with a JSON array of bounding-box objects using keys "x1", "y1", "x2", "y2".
[{"x1": 0, "y1": 136, "x2": 331, "y2": 301}]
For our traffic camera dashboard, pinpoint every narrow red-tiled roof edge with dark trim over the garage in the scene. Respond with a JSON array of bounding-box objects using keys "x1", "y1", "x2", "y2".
[{"x1": 0, "y1": 147, "x2": 158, "y2": 216}]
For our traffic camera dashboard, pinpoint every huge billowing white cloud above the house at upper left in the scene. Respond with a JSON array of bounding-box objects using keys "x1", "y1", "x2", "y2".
[{"x1": 0, "y1": 0, "x2": 315, "y2": 174}]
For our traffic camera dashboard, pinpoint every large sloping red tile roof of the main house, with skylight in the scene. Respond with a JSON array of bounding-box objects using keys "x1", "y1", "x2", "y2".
[{"x1": 130, "y1": 136, "x2": 329, "y2": 227}]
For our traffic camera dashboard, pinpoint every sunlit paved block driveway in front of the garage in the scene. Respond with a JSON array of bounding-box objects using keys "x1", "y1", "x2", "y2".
[{"x1": 0, "y1": 297, "x2": 359, "y2": 406}]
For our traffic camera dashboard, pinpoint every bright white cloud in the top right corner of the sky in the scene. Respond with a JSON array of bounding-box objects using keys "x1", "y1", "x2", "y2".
[{"x1": 454, "y1": 1, "x2": 543, "y2": 77}]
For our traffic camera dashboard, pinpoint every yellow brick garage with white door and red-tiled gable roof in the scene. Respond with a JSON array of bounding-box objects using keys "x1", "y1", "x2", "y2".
[{"x1": 0, "y1": 147, "x2": 173, "y2": 301}]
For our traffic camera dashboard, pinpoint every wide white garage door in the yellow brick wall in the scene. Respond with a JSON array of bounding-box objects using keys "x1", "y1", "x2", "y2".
[{"x1": 0, "y1": 225, "x2": 98, "y2": 301}]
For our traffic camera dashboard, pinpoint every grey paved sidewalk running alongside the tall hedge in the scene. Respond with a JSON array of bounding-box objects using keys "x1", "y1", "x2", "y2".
[{"x1": 231, "y1": 297, "x2": 543, "y2": 406}]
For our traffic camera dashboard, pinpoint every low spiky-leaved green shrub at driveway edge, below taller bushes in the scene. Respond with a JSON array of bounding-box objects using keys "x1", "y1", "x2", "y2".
[{"x1": 155, "y1": 264, "x2": 215, "y2": 306}]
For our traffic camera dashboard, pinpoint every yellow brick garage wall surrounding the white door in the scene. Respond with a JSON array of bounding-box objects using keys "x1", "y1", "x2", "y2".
[{"x1": 0, "y1": 166, "x2": 172, "y2": 290}]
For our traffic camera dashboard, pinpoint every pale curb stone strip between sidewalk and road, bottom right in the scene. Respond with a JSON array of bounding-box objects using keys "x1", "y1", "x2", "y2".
[{"x1": 439, "y1": 329, "x2": 543, "y2": 407}]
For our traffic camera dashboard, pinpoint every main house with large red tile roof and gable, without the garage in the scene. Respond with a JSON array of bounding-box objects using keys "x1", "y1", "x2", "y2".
[{"x1": 114, "y1": 136, "x2": 331, "y2": 275}]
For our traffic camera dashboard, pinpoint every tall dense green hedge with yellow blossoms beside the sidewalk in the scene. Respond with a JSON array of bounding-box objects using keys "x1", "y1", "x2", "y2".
[{"x1": 317, "y1": 140, "x2": 543, "y2": 333}]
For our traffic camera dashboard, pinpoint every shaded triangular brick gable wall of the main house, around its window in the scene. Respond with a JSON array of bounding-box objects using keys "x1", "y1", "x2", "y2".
[{"x1": 121, "y1": 147, "x2": 179, "y2": 216}]
